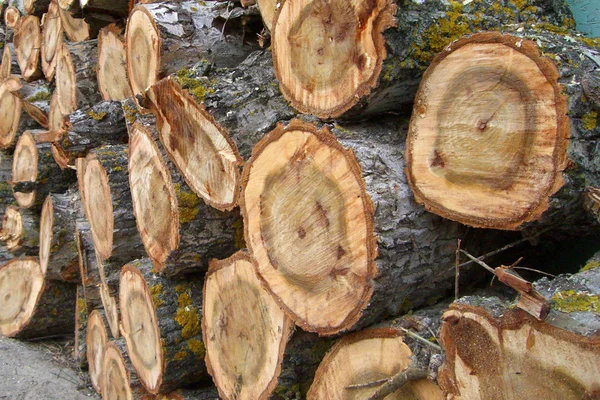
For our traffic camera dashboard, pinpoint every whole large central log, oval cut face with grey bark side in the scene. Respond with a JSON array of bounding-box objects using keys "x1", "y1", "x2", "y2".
[{"x1": 240, "y1": 120, "x2": 515, "y2": 334}]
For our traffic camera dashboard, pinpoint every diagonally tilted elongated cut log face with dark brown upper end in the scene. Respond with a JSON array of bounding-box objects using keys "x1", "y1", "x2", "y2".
[{"x1": 147, "y1": 78, "x2": 242, "y2": 210}]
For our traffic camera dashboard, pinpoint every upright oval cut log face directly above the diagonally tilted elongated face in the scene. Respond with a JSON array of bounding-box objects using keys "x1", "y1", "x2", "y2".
[{"x1": 125, "y1": 6, "x2": 160, "y2": 102}]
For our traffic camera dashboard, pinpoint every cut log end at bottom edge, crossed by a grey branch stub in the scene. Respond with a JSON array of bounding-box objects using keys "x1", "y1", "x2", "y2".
[{"x1": 306, "y1": 328, "x2": 443, "y2": 400}]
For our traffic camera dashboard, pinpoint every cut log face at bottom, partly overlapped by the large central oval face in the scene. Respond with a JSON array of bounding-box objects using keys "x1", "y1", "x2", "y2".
[{"x1": 202, "y1": 253, "x2": 292, "y2": 399}]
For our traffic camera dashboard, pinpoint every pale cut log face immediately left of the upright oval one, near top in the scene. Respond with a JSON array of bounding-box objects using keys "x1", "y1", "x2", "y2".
[{"x1": 97, "y1": 24, "x2": 132, "y2": 100}]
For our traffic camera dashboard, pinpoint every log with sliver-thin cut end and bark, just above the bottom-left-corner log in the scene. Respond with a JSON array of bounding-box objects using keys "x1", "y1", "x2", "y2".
[{"x1": 39, "y1": 189, "x2": 83, "y2": 282}]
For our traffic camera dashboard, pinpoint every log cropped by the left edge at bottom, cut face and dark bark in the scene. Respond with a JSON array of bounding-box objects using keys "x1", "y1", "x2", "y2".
[{"x1": 0, "y1": 257, "x2": 76, "y2": 339}]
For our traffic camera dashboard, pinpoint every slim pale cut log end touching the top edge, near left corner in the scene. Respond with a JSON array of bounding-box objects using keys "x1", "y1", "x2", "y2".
[{"x1": 41, "y1": 2, "x2": 63, "y2": 81}]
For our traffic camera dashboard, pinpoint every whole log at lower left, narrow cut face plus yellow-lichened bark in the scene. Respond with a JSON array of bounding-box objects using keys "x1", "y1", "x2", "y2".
[{"x1": 119, "y1": 258, "x2": 208, "y2": 394}]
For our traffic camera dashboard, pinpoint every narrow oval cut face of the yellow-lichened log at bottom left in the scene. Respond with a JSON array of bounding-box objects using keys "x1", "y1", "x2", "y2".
[{"x1": 119, "y1": 265, "x2": 163, "y2": 394}]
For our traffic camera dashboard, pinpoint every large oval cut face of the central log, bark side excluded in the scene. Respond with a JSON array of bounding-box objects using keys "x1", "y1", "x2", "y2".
[{"x1": 241, "y1": 120, "x2": 377, "y2": 334}]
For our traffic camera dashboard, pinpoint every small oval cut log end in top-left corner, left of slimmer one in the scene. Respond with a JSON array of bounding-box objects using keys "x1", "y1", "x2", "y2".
[{"x1": 14, "y1": 15, "x2": 42, "y2": 81}]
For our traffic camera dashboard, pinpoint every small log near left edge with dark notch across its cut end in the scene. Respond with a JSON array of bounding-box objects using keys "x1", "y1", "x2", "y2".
[{"x1": 12, "y1": 131, "x2": 76, "y2": 210}]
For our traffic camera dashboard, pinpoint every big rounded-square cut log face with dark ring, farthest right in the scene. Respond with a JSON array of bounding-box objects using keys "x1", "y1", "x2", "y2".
[{"x1": 406, "y1": 33, "x2": 569, "y2": 229}]
